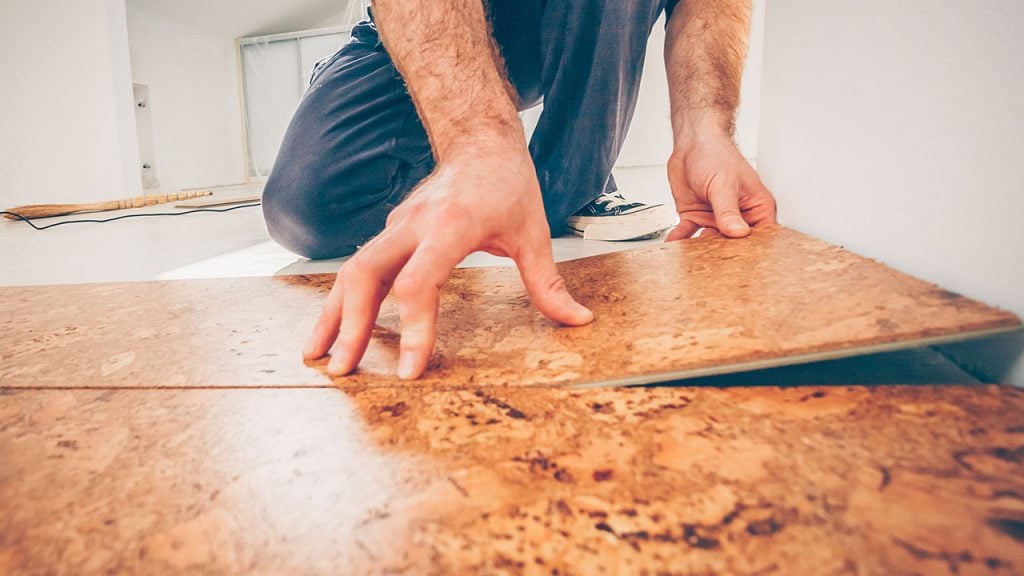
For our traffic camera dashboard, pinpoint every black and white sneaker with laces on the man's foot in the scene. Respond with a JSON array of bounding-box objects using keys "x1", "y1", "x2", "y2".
[{"x1": 566, "y1": 192, "x2": 678, "y2": 242}]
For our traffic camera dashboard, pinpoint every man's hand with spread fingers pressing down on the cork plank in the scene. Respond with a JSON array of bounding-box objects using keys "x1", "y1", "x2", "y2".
[{"x1": 305, "y1": 150, "x2": 594, "y2": 379}]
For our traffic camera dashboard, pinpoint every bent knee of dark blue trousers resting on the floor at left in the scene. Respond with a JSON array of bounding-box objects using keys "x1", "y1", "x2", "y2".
[{"x1": 263, "y1": 28, "x2": 433, "y2": 258}]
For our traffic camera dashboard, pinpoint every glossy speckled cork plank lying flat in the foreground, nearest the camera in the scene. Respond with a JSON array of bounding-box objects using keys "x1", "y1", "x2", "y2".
[{"x1": 0, "y1": 385, "x2": 1024, "y2": 575}]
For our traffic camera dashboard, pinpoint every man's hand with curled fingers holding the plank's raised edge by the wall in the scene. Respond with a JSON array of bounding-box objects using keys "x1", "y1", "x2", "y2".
[{"x1": 666, "y1": 133, "x2": 775, "y2": 241}]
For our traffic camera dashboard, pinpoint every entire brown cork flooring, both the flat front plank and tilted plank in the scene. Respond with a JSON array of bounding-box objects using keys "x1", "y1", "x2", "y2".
[{"x1": 0, "y1": 223, "x2": 1024, "y2": 575}]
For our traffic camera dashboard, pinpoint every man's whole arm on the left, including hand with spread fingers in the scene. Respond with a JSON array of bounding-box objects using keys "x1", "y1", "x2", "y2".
[{"x1": 304, "y1": 0, "x2": 593, "y2": 378}]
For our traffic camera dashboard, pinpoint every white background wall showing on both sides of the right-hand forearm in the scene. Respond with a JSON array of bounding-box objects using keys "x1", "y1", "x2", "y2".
[{"x1": 616, "y1": 0, "x2": 765, "y2": 167}]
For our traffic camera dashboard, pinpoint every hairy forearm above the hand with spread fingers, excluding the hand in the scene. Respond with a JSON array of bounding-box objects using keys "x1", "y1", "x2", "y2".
[{"x1": 373, "y1": 0, "x2": 526, "y2": 163}]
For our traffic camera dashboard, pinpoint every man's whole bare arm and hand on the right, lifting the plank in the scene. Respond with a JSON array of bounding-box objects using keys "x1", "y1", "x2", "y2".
[{"x1": 665, "y1": 0, "x2": 775, "y2": 240}]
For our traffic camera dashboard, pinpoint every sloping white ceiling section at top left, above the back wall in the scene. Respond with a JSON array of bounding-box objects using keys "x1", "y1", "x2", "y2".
[{"x1": 125, "y1": 0, "x2": 362, "y2": 38}]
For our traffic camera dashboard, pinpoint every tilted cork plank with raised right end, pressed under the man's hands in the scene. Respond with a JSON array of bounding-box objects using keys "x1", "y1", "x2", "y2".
[{"x1": 0, "y1": 227, "x2": 1020, "y2": 387}]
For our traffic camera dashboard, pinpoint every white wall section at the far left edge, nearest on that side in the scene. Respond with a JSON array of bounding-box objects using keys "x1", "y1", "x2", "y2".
[{"x1": 0, "y1": 0, "x2": 141, "y2": 207}]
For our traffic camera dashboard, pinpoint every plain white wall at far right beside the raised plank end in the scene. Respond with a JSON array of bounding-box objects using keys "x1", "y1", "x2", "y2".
[{"x1": 758, "y1": 0, "x2": 1024, "y2": 384}]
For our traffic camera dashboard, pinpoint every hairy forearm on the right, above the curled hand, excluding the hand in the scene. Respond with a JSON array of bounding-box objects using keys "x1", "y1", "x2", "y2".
[{"x1": 665, "y1": 0, "x2": 751, "y2": 143}]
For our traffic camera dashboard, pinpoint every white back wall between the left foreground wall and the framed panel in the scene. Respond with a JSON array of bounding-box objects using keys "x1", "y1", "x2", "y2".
[{"x1": 128, "y1": 8, "x2": 245, "y2": 192}]
